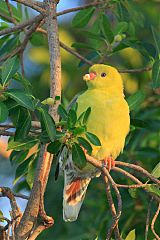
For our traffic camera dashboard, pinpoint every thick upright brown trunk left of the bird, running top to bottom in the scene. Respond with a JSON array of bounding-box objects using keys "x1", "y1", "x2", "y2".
[{"x1": 15, "y1": 0, "x2": 61, "y2": 240}]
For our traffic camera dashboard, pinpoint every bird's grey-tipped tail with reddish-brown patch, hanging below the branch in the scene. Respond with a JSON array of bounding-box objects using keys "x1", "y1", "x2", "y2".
[{"x1": 63, "y1": 172, "x2": 91, "y2": 222}]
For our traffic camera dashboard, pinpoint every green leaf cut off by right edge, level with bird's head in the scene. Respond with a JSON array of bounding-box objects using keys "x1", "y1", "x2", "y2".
[{"x1": 152, "y1": 60, "x2": 160, "y2": 89}]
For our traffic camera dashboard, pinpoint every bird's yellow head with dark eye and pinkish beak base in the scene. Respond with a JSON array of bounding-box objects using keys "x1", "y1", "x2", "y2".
[{"x1": 83, "y1": 64, "x2": 123, "y2": 94}]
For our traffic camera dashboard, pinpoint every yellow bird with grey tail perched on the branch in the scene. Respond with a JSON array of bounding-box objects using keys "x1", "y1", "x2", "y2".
[{"x1": 63, "y1": 64, "x2": 130, "y2": 221}]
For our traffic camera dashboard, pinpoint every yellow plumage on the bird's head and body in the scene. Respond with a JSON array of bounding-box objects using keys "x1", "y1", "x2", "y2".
[{"x1": 78, "y1": 64, "x2": 130, "y2": 160}]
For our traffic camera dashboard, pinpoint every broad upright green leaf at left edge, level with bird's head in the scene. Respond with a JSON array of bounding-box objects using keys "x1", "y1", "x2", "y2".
[{"x1": 2, "y1": 57, "x2": 19, "y2": 86}]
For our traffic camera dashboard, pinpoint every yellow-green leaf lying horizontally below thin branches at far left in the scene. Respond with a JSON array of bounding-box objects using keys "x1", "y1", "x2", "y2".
[{"x1": 7, "y1": 138, "x2": 38, "y2": 151}]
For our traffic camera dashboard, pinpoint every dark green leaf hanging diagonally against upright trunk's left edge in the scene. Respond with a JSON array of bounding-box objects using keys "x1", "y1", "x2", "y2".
[{"x1": 38, "y1": 108, "x2": 56, "y2": 142}]
